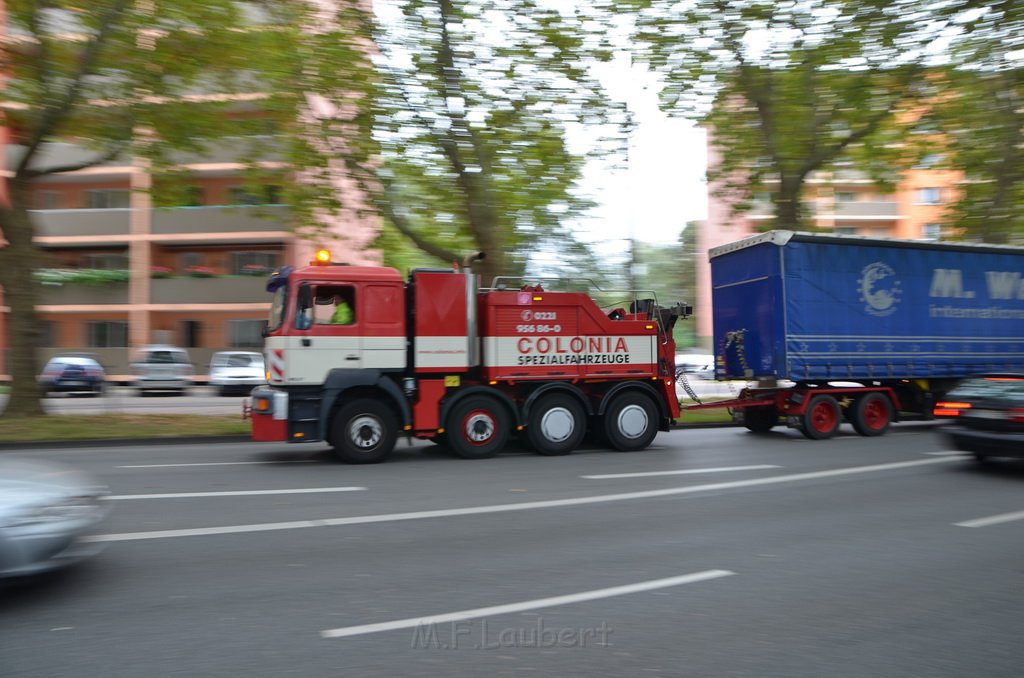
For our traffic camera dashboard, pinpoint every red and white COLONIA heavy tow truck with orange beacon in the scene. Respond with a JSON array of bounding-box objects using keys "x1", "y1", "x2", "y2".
[{"x1": 250, "y1": 251, "x2": 690, "y2": 463}]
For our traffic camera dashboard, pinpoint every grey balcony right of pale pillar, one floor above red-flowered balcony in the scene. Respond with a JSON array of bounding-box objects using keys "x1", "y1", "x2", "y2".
[{"x1": 151, "y1": 205, "x2": 289, "y2": 236}]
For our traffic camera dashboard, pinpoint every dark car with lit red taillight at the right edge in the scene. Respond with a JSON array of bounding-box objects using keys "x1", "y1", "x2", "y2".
[{"x1": 934, "y1": 374, "x2": 1024, "y2": 461}]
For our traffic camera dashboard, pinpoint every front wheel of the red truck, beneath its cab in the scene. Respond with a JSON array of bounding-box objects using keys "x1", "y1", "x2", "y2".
[{"x1": 331, "y1": 398, "x2": 398, "y2": 464}]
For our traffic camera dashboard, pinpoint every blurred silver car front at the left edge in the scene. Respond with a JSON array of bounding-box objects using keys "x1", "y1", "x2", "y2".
[{"x1": 0, "y1": 459, "x2": 109, "y2": 578}]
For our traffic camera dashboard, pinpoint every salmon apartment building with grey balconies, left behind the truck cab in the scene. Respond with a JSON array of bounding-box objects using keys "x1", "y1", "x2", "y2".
[{"x1": 0, "y1": 140, "x2": 380, "y2": 377}]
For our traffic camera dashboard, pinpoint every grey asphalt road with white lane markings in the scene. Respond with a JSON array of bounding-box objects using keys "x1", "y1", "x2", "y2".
[{"x1": 0, "y1": 423, "x2": 1024, "y2": 678}]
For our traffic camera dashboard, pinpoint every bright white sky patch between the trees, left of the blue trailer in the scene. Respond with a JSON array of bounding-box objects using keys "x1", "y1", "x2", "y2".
[{"x1": 570, "y1": 58, "x2": 708, "y2": 246}]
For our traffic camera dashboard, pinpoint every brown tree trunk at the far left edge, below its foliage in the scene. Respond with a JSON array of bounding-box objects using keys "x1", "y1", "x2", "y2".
[{"x1": 0, "y1": 178, "x2": 46, "y2": 417}]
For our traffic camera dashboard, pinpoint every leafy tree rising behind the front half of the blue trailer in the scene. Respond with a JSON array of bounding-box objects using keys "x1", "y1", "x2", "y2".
[{"x1": 634, "y1": 0, "x2": 954, "y2": 228}]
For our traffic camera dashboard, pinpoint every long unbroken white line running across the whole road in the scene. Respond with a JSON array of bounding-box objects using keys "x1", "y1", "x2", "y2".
[{"x1": 82, "y1": 457, "x2": 957, "y2": 542}]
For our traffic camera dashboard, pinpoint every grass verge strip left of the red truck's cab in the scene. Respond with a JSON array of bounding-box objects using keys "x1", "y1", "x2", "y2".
[{"x1": 0, "y1": 414, "x2": 249, "y2": 442}]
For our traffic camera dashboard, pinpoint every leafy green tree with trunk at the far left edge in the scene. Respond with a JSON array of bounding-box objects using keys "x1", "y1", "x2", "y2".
[{"x1": 0, "y1": 0, "x2": 369, "y2": 416}]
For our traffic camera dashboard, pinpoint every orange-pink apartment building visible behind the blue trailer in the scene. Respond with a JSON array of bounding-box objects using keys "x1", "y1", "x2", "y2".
[{"x1": 696, "y1": 144, "x2": 962, "y2": 349}]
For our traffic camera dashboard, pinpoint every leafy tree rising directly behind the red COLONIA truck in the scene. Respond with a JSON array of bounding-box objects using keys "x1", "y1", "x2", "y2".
[{"x1": 311, "y1": 0, "x2": 622, "y2": 281}]
